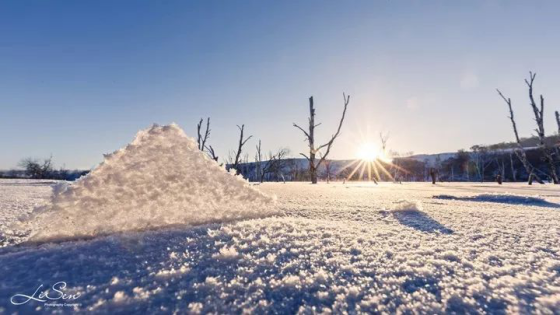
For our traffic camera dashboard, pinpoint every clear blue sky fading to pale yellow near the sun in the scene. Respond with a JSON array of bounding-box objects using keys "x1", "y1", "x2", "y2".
[{"x1": 0, "y1": 0, "x2": 560, "y2": 169}]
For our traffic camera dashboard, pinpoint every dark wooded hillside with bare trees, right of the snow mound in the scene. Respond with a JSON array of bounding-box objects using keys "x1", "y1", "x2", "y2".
[{"x1": 197, "y1": 78, "x2": 560, "y2": 184}]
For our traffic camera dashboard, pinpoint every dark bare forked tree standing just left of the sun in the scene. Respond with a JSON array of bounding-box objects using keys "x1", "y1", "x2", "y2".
[{"x1": 293, "y1": 93, "x2": 350, "y2": 184}]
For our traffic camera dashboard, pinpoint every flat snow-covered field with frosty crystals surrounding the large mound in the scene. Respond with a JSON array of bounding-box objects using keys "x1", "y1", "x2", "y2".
[{"x1": 0, "y1": 180, "x2": 560, "y2": 314}]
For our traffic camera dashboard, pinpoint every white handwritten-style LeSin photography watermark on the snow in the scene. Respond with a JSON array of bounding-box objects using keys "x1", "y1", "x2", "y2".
[{"x1": 10, "y1": 281, "x2": 81, "y2": 307}]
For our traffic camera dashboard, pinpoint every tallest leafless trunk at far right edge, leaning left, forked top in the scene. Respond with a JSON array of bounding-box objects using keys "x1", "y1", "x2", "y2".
[{"x1": 525, "y1": 72, "x2": 559, "y2": 184}]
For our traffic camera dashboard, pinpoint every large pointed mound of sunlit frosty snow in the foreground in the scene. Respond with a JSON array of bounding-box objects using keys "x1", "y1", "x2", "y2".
[{"x1": 22, "y1": 124, "x2": 273, "y2": 241}]
